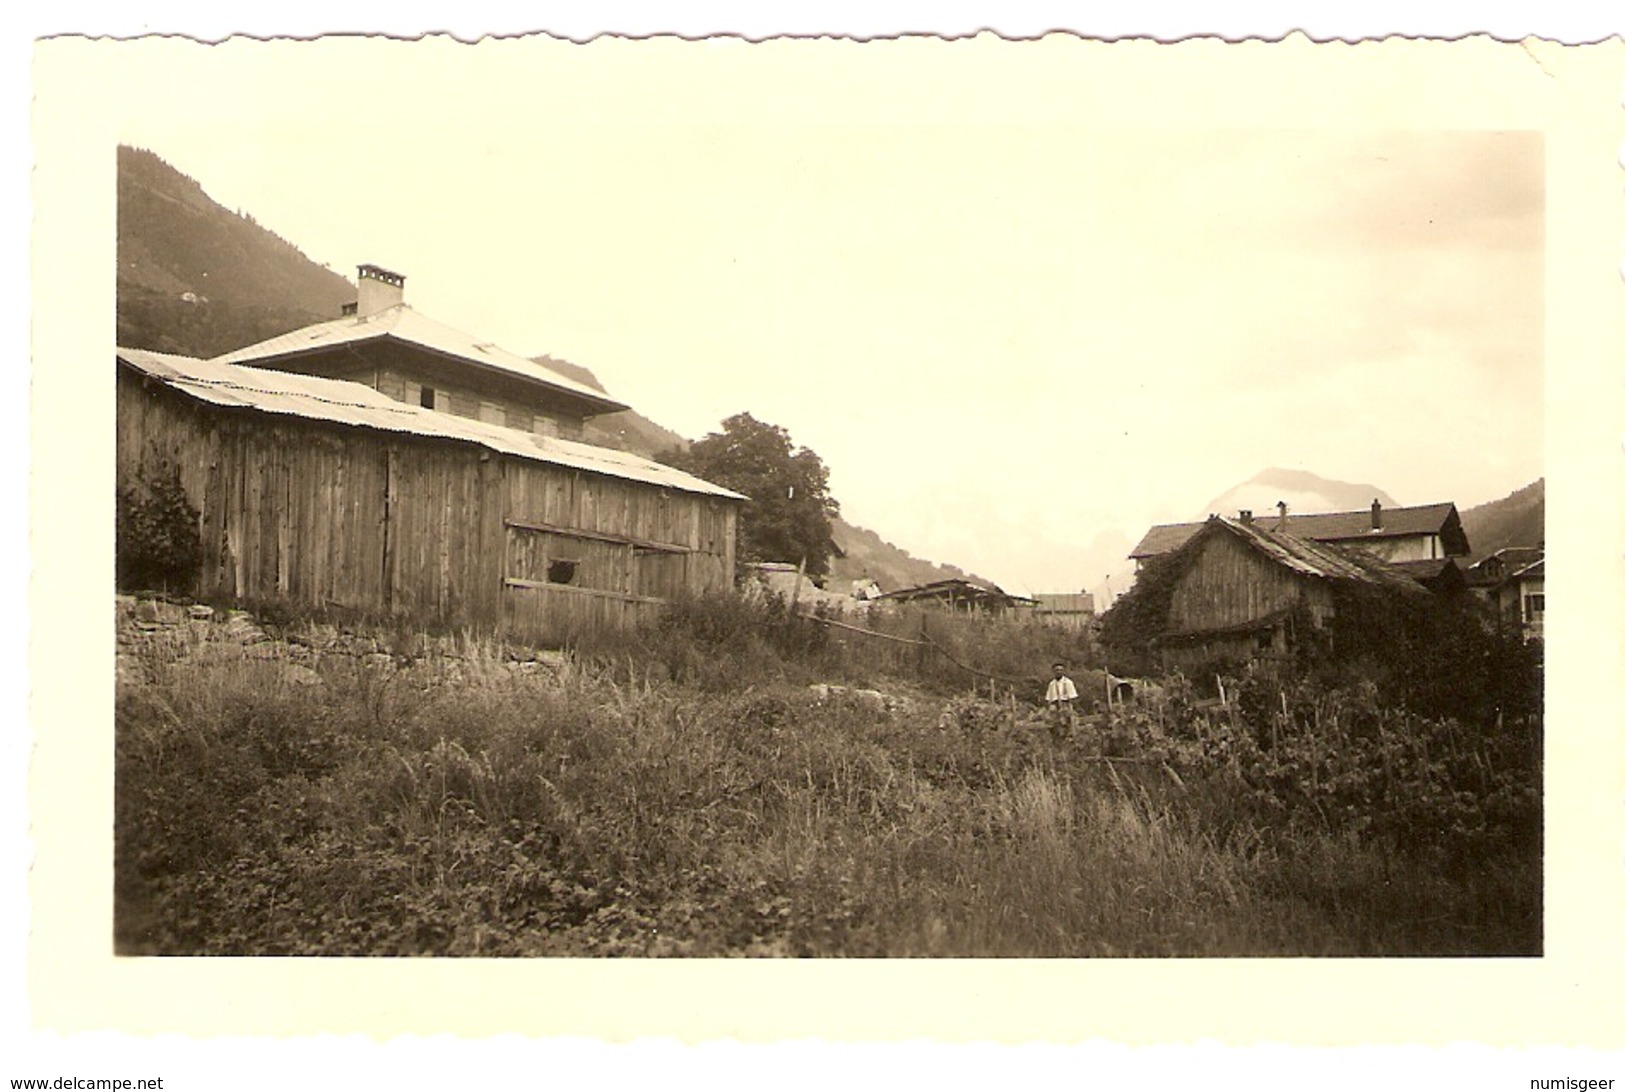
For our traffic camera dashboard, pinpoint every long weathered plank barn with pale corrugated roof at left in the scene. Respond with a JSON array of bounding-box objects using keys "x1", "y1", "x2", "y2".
[{"x1": 117, "y1": 349, "x2": 744, "y2": 642}]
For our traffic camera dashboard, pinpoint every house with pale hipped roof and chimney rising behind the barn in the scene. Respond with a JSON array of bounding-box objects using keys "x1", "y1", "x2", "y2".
[{"x1": 215, "y1": 265, "x2": 627, "y2": 440}]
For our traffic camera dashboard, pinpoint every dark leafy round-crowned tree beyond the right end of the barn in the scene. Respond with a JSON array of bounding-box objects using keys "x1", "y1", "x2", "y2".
[{"x1": 666, "y1": 413, "x2": 840, "y2": 577}]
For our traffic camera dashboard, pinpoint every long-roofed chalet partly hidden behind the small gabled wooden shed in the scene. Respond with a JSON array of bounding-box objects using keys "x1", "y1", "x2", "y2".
[{"x1": 1129, "y1": 501, "x2": 1472, "y2": 572}]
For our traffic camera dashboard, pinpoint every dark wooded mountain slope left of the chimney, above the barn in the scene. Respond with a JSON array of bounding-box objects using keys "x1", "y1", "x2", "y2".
[{"x1": 117, "y1": 146, "x2": 356, "y2": 356}]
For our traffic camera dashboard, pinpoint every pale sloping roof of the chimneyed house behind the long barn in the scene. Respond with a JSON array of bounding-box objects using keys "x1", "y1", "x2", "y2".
[{"x1": 213, "y1": 304, "x2": 627, "y2": 413}]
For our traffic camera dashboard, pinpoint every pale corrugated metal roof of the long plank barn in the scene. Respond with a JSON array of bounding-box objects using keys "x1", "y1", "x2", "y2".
[{"x1": 117, "y1": 349, "x2": 744, "y2": 501}]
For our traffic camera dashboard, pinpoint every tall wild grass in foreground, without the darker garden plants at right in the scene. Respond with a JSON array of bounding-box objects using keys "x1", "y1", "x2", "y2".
[{"x1": 115, "y1": 608, "x2": 1539, "y2": 956}]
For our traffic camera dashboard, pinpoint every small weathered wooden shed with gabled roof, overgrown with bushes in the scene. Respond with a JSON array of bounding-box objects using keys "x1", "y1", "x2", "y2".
[{"x1": 1154, "y1": 515, "x2": 1432, "y2": 670}]
